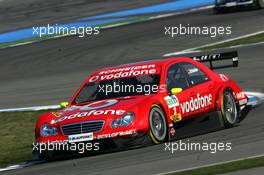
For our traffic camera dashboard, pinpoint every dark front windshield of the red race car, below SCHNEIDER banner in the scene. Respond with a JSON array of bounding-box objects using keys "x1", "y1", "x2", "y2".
[{"x1": 74, "y1": 74, "x2": 160, "y2": 104}]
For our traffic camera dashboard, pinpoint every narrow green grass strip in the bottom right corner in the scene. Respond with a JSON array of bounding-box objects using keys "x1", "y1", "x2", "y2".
[{"x1": 170, "y1": 157, "x2": 264, "y2": 175}]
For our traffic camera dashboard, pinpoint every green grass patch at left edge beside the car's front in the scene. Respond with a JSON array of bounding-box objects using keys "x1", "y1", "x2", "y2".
[{"x1": 0, "y1": 111, "x2": 50, "y2": 167}]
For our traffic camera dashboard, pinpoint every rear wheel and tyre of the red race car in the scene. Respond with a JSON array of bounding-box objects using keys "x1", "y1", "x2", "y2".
[{"x1": 221, "y1": 90, "x2": 239, "y2": 128}]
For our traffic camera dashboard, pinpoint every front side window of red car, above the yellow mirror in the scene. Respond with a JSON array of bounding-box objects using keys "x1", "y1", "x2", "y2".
[{"x1": 166, "y1": 64, "x2": 189, "y2": 91}]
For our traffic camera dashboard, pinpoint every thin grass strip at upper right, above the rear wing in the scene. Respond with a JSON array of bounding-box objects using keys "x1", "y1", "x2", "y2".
[{"x1": 198, "y1": 33, "x2": 264, "y2": 50}]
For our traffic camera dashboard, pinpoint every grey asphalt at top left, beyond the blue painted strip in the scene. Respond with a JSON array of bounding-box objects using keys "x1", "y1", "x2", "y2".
[{"x1": 0, "y1": 0, "x2": 168, "y2": 33}]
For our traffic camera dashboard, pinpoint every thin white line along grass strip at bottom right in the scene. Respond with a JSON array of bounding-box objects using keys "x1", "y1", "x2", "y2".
[{"x1": 157, "y1": 154, "x2": 264, "y2": 175}]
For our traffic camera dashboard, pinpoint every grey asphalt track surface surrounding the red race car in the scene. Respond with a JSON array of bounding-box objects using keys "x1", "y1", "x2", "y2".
[{"x1": 0, "y1": 4, "x2": 264, "y2": 174}]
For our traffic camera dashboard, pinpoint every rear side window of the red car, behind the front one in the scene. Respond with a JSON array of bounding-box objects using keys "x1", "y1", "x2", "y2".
[{"x1": 181, "y1": 63, "x2": 209, "y2": 86}]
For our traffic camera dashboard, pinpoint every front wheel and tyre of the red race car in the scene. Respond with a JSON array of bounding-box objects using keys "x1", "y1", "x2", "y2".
[{"x1": 149, "y1": 104, "x2": 168, "y2": 144}]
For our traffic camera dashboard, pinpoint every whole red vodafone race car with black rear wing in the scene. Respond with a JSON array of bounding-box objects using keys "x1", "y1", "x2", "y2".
[{"x1": 34, "y1": 52, "x2": 248, "y2": 159}]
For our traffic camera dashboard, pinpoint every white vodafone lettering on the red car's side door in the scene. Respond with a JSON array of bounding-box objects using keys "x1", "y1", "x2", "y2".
[{"x1": 181, "y1": 93, "x2": 212, "y2": 114}]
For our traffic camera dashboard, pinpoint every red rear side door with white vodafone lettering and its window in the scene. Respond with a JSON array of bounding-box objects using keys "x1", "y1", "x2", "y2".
[{"x1": 180, "y1": 62, "x2": 215, "y2": 117}]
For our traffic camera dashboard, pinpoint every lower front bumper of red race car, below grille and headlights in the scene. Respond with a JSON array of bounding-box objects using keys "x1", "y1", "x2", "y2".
[{"x1": 33, "y1": 130, "x2": 146, "y2": 159}]
